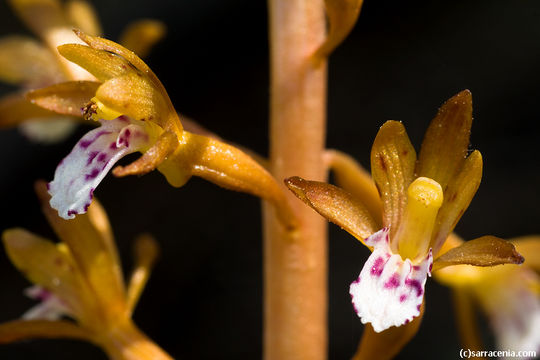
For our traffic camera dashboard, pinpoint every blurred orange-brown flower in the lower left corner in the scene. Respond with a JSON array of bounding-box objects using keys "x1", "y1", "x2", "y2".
[{"x1": 0, "y1": 182, "x2": 171, "y2": 360}]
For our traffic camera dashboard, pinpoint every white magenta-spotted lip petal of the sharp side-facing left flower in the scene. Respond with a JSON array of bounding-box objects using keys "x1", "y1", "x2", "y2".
[{"x1": 49, "y1": 117, "x2": 149, "y2": 219}]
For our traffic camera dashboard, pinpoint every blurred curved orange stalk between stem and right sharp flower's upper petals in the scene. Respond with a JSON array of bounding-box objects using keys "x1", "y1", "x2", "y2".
[{"x1": 324, "y1": 150, "x2": 382, "y2": 228}]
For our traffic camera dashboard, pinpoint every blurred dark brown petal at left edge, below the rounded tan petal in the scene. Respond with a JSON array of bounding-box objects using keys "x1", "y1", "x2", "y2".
[{"x1": 0, "y1": 94, "x2": 58, "y2": 128}]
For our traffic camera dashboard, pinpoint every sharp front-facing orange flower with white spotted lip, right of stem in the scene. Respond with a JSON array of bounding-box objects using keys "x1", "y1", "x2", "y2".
[{"x1": 285, "y1": 91, "x2": 523, "y2": 332}]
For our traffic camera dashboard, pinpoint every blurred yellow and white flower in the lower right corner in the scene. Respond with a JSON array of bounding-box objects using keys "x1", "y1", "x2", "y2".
[{"x1": 435, "y1": 236, "x2": 540, "y2": 358}]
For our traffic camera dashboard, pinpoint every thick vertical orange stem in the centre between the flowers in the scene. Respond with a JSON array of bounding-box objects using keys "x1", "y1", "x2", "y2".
[{"x1": 264, "y1": 0, "x2": 327, "y2": 360}]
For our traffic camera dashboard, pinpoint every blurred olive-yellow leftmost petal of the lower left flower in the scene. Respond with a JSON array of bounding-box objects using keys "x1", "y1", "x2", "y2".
[{"x1": 3, "y1": 229, "x2": 95, "y2": 321}]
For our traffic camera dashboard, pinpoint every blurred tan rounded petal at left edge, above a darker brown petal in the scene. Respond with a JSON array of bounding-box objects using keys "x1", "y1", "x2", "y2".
[{"x1": 0, "y1": 36, "x2": 62, "y2": 88}]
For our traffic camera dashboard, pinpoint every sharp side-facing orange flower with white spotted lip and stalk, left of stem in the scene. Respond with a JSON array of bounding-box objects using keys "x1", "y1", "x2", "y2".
[{"x1": 28, "y1": 32, "x2": 292, "y2": 226}]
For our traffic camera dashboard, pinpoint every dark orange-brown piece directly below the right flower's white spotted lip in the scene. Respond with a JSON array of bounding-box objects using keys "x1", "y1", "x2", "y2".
[{"x1": 352, "y1": 303, "x2": 425, "y2": 360}]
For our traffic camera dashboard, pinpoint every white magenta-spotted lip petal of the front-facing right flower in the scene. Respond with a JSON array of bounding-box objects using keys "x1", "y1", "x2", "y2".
[{"x1": 349, "y1": 228, "x2": 433, "y2": 332}]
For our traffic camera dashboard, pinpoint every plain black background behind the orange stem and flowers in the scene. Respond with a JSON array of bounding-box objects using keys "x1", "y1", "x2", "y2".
[{"x1": 0, "y1": 0, "x2": 540, "y2": 359}]
